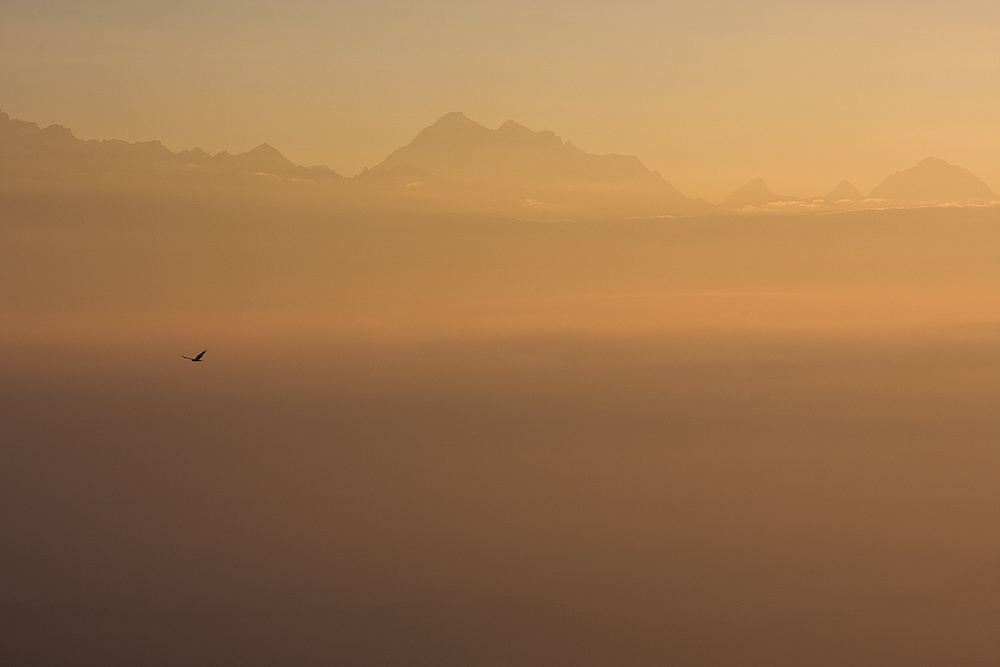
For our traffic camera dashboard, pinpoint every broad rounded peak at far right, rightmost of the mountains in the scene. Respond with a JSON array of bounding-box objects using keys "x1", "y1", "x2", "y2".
[{"x1": 868, "y1": 157, "x2": 1000, "y2": 204}]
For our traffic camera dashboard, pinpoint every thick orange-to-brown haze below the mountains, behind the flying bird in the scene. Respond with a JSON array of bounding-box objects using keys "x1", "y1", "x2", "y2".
[{"x1": 0, "y1": 176, "x2": 1000, "y2": 667}]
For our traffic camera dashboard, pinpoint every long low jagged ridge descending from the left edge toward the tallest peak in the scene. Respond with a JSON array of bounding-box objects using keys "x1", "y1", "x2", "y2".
[{"x1": 0, "y1": 112, "x2": 341, "y2": 180}]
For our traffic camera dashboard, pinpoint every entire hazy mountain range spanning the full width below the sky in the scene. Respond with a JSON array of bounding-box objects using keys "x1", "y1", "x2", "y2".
[{"x1": 0, "y1": 112, "x2": 1000, "y2": 218}]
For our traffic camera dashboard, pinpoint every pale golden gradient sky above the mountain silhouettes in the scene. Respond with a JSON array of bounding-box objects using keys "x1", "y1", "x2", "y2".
[{"x1": 0, "y1": 0, "x2": 1000, "y2": 201}]
